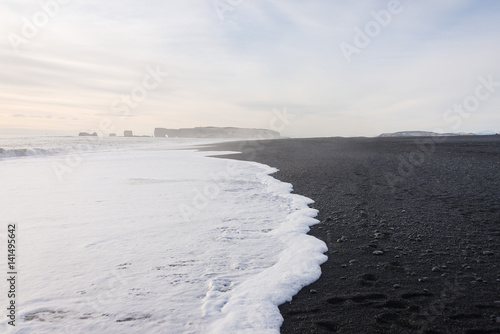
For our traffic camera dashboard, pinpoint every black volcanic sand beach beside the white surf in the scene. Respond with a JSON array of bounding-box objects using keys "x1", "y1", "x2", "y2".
[{"x1": 206, "y1": 136, "x2": 500, "y2": 334}]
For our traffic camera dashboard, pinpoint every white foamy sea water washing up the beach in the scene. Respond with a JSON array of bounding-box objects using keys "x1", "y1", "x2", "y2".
[{"x1": 0, "y1": 137, "x2": 327, "y2": 334}]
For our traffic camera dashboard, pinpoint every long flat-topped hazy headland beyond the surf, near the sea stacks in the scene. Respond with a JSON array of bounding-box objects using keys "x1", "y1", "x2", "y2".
[{"x1": 154, "y1": 126, "x2": 281, "y2": 139}]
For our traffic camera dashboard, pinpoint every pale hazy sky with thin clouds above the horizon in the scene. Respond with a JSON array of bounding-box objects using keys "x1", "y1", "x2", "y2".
[{"x1": 0, "y1": 0, "x2": 500, "y2": 137}]
